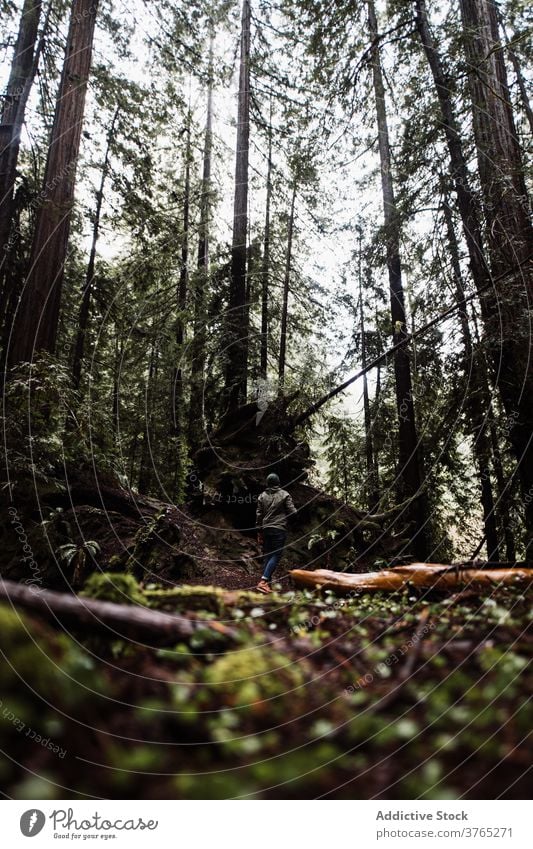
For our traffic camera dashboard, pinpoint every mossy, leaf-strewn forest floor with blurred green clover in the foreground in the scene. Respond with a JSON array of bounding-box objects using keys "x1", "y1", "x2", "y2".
[{"x1": 0, "y1": 567, "x2": 533, "y2": 799}]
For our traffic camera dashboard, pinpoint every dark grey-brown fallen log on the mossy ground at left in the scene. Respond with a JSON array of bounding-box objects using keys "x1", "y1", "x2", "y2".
[{"x1": 0, "y1": 580, "x2": 237, "y2": 646}]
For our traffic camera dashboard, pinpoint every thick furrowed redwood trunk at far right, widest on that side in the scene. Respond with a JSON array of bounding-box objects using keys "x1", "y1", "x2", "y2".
[{"x1": 460, "y1": 0, "x2": 533, "y2": 559}]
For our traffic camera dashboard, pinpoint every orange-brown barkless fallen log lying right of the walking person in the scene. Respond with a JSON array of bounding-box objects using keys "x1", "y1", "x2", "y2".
[{"x1": 289, "y1": 563, "x2": 533, "y2": 595}]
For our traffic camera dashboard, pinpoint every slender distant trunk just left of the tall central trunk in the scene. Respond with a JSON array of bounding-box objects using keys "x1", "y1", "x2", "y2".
[{"x1": 188, "y1": 45, "x2": 214, "y2": 456}]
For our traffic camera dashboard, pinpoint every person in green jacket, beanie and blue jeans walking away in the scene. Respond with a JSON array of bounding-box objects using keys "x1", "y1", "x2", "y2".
[{"x1": 256, "y1": 474, "x2": 296, "y2": 593}]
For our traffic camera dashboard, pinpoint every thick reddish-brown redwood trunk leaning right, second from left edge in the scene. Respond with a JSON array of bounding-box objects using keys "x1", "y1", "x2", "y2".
[{"x1": 8, "y1": 0, "x2": 98, "y2": 365}]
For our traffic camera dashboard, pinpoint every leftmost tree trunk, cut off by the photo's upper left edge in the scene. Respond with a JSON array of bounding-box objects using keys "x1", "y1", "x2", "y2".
[{"x1": 0, "y1": 0, "x2": 43, "y2": 298}]
